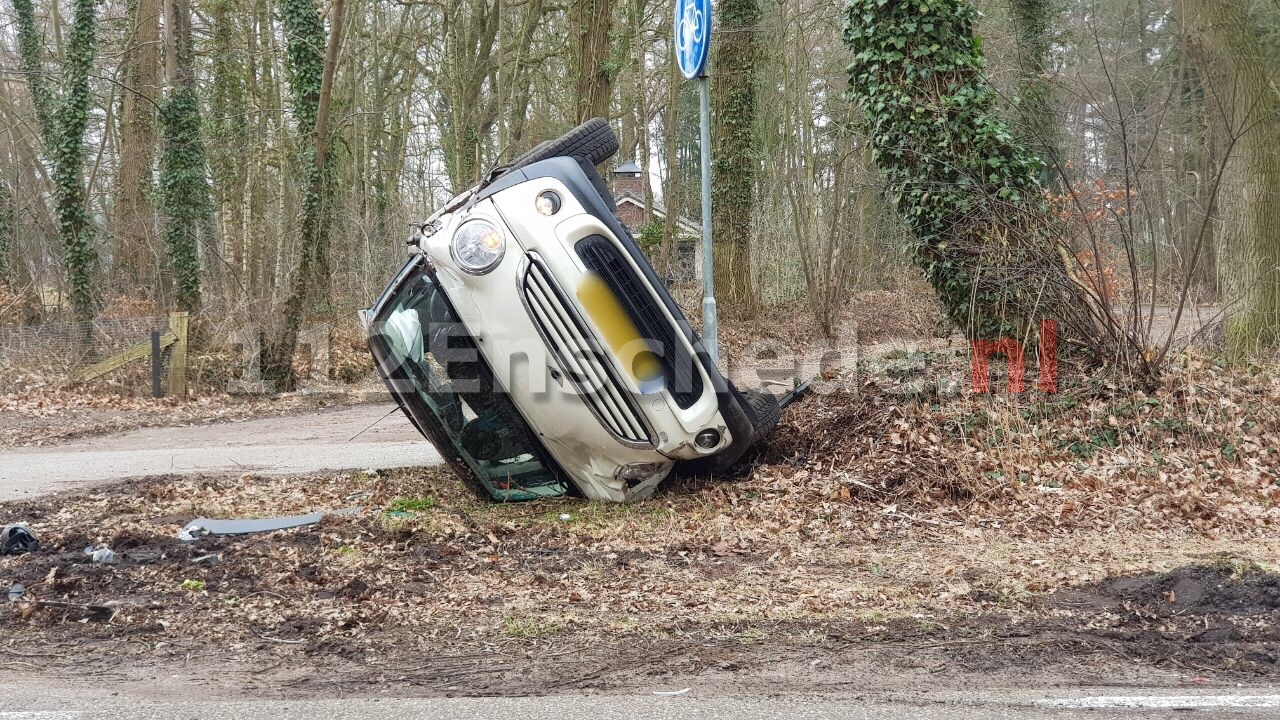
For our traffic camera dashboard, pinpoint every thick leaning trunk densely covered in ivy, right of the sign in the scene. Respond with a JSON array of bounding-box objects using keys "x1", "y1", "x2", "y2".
[{"x1": 845, "y1": 0, "x2": 1064, "y2": 338}]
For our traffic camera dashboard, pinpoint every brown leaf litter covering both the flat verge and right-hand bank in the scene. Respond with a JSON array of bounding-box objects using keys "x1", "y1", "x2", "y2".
[{"x1": 0, "y1": 360, "x2": 1280, "y2": 647}]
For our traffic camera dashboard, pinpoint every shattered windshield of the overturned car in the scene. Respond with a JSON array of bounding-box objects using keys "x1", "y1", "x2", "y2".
[{"x1": 369, "y1": 261, "x2": 566, "y2": 501}]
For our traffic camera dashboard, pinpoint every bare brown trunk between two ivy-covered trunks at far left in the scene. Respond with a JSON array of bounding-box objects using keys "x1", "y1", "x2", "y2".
[{"x1": 111, "y1": 0, "x2": 161, "y2": 295}]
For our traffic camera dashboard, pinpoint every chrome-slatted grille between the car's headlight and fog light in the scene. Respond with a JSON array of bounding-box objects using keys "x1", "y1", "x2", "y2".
[{"x1": 521, "y1": 254, "x2": 653, "y2": 446}]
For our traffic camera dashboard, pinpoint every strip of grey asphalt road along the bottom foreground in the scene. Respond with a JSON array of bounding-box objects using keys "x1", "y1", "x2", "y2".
[{"x1": 0, "y1": 683, "x2": 1280, "y2": 720}]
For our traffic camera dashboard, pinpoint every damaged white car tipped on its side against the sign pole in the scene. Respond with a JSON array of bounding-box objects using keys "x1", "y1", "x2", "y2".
[{"x1": 364, "y1": 119, "x2": 790, "y2": 502}]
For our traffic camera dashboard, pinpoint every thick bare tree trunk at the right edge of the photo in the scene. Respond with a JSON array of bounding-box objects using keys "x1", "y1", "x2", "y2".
[{"x1": 1176, "y1": 0, "x2": 1280, "y2": 356}]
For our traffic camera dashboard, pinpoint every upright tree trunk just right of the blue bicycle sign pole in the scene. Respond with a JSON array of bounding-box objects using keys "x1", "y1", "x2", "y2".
[{"x1": 712, "y1": 0, "x2": 760, "y2": 318}]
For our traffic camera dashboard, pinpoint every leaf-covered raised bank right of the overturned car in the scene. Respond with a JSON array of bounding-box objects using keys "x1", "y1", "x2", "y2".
[{"x1": 756, "y1": 351, "x2": 1280, "y2": 532}]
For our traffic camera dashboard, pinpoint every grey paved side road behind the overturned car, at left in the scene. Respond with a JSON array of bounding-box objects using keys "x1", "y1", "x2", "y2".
[{"x1": 0, "y1": 404, "x2": 440, "y2": 499}]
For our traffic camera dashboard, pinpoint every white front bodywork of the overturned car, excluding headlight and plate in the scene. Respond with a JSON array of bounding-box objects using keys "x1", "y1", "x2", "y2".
[{"x1": 422, "y1": 171, "x2": 749, "y2": 501}]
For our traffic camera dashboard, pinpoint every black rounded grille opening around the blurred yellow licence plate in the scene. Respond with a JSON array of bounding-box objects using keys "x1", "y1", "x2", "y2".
[{"x1": 576, "y1": 234, "x2": 703, "y2": 409}]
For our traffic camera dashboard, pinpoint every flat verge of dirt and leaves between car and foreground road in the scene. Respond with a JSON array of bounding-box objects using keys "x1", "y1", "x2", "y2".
[{"x1": 0, "y1": 470, "x2": 1280, "y2": 696}]
